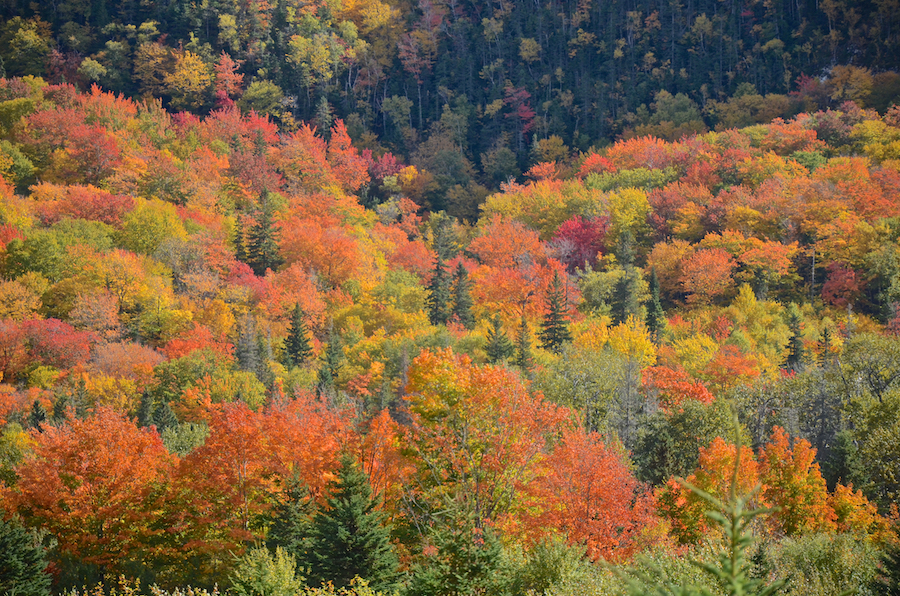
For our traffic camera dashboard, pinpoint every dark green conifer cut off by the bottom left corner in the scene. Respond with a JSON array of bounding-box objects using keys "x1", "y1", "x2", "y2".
[{"x1": 0, "y1": 517, "x2": 51, "y2": 596}]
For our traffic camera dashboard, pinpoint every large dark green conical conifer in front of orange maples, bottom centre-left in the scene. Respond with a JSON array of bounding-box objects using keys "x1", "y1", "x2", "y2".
[{"x1": 310, "y1": 456, "x2": 399, "y2": 592}]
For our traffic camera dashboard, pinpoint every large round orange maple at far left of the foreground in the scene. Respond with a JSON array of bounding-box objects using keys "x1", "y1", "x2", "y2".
[{"x1": 2, "y1": 407, "x2": 176, "y2": 571}]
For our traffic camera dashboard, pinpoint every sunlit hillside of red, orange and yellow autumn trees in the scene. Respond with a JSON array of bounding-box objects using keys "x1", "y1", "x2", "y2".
[{"x1": 0, "y1": 77, "x2": 900, "y2": 594}]
